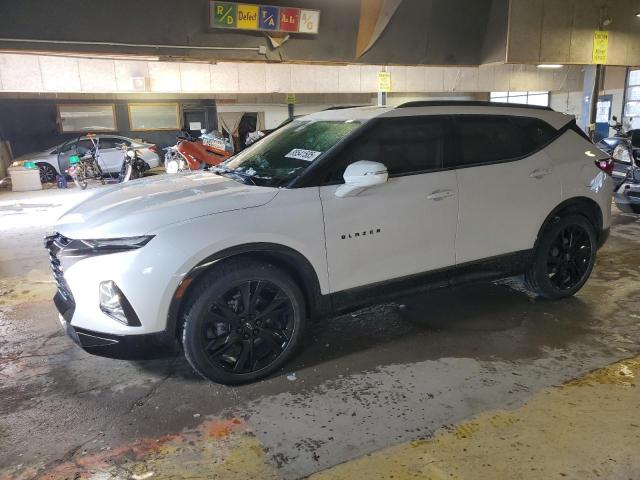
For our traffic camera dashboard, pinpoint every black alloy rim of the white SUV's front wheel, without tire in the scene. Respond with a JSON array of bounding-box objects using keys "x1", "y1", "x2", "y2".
[{"x1": 201, "y1": 280, "x2": 294, "y2": 374}]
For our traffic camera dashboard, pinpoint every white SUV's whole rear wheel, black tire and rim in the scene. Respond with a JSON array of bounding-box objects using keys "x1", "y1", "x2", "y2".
[{"x1": 525, "y1": 215, "x2": 597, "y2": 300}]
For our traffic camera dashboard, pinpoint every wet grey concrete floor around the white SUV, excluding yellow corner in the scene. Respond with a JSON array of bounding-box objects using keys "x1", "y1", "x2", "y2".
[{"x1": 0, "y1": 186, "x2": 640, "y2": 480}]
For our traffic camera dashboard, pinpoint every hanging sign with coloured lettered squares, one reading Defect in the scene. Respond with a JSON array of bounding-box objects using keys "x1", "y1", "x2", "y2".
[{"x1": 209, "y1": 1, "x2": 320, "y2": 34}]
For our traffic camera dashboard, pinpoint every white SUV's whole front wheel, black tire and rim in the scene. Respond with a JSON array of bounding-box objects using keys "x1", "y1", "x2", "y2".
[{"x1": 182, "y1": 260, "x2": 306, "y2": 385}]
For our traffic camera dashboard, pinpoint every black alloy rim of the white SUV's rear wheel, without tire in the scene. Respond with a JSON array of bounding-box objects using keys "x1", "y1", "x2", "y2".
[{"x1": 547, "y1": 225, "x2": 593, "y2": 291}]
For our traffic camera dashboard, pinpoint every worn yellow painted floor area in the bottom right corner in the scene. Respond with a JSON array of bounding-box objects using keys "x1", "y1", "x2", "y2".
[{"x1": 311, "y1": 357, "x2": 640, "y2": 480}]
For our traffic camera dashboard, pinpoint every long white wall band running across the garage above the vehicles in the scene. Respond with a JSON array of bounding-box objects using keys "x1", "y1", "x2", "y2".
[{"x1": 0, "y1": 54, "x2": 582, "y2": 94}]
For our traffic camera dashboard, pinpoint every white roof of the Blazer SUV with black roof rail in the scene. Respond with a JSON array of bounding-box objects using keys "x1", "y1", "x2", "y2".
[{"x1": 297, "y1": 100, "x2": 574, "y2": 128}]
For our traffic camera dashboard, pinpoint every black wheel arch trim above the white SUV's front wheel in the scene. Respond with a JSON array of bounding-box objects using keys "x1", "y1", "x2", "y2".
[{"x1": 167, "y1": 242, "x2": 332, "y2": 336}]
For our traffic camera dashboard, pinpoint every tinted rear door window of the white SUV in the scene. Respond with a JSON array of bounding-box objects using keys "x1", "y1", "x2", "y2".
[{"x1": 448, "y1": 115, "x2": 556, "y2": 166}]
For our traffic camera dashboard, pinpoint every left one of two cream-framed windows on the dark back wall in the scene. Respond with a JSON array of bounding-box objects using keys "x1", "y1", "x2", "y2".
[{"x1": 58, "y1": 104, "x2": 116, "y2": 133}]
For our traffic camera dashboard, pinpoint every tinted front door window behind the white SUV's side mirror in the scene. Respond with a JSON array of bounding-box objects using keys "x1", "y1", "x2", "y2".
[{"x1": 326, "y1": 117, "x2": 444, "y2": 182}]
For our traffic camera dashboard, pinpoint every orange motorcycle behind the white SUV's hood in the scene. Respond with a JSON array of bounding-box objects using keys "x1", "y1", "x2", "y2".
[{"x1": 165, "y1": 129, "x2": 233, "y2": 173}]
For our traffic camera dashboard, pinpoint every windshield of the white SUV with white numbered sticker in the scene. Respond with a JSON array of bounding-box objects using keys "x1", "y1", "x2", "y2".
[{"x1": 219, "y1": 120, "x2": 361, "y2": 187}]
